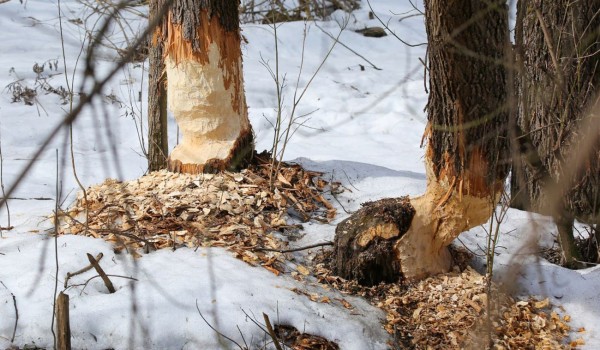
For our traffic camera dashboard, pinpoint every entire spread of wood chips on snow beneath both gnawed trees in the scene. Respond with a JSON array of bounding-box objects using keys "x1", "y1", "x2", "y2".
[{"x1": 59, "y1": 164, "x2": 585, "y2": 349}]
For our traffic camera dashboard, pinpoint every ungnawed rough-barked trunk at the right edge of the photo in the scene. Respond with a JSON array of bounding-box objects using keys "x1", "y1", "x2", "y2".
[{"x1": 511, "y1": 0, "x2": 600, "y2": 266}]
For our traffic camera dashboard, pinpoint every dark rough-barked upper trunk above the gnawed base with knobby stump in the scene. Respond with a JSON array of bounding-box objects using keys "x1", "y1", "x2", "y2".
[{"x1": 425, "y1": 0, "x2": 510, "y2": 193}]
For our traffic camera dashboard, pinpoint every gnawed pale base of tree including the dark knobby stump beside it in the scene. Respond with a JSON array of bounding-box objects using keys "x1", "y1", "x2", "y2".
[{"x1": 333, "y1": 175, "x2": 501, "y2": 285}]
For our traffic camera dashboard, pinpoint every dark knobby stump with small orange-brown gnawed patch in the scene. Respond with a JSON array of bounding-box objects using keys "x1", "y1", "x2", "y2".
[{"x1": 333, "y1": 197, "x2": 415, "y2": 286}]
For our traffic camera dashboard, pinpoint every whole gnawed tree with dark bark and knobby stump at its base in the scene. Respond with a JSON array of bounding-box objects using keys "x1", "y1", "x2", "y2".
[{"x1": 334, "y1": 0, "x2": 509, "y2": 284}]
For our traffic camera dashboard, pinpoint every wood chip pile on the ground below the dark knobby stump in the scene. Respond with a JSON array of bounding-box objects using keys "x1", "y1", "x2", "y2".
[{"x1": 315, "y1": 264, "x2": 585, "y2": 349}]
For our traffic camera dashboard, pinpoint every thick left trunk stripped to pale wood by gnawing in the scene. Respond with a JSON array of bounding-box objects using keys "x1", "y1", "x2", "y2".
[{"x1": 160, "y1": 0, "x2": 254, "y2": 173}]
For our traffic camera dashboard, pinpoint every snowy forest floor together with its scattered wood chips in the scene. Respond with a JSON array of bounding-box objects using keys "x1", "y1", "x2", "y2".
[{"x1": 0, "y1": 0, "x2": 600, "y2": 350}]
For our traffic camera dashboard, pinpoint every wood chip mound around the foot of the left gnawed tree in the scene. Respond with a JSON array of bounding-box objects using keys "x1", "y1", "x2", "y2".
[{"x1": 59, "y1": 164, "x2": 335, "y2": 273}]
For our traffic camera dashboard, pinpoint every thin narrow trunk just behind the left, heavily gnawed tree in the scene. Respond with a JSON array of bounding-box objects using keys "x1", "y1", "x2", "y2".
[{"x1": 148, "y1": 0, "x2": 169, "y2": 171}]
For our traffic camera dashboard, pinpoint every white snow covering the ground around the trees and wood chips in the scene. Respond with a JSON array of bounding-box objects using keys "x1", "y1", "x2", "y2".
[{"x1": 0, "y1": 0, "x2": 600, "y2": 349}]
